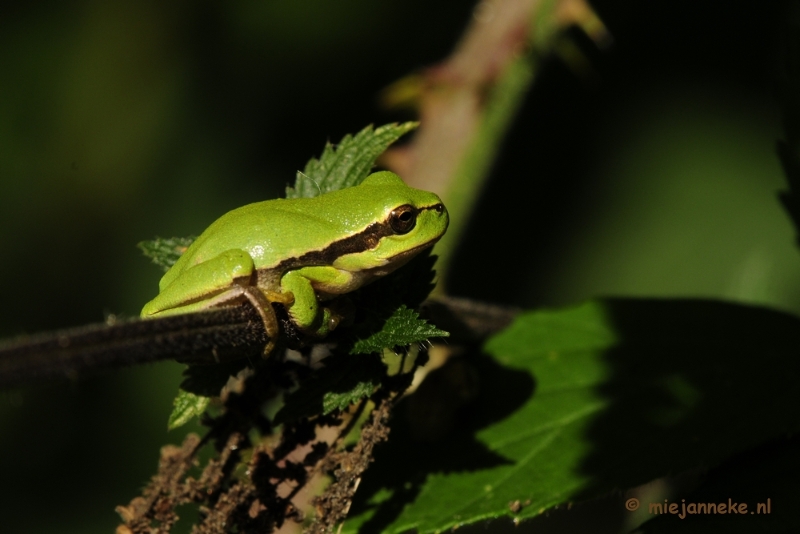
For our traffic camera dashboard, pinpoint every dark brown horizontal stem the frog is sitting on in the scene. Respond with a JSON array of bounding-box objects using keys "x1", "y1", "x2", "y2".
[{"x1": 0, "y1": 298, "x2": 516, "y2": 387}]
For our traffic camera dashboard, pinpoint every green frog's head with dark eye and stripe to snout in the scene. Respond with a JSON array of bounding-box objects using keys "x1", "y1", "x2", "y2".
[{"x1": 333, "y1": 172, "x2": 450, "y2": 276}]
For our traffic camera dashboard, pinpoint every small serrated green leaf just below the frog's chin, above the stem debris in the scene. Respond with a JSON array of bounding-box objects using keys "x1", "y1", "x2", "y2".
[{"x1": 350, "y1": 304, "x2": 450, "y2": 354}]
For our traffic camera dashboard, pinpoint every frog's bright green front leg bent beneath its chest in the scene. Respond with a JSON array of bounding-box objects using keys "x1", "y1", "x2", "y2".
[{"x1": 281, "y1": 266, "x2": 353, "y2": 336}]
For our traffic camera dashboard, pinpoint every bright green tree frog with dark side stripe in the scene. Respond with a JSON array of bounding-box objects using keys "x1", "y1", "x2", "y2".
[{"x1": 141, "y1": 172, "x2": 449, "y2": 356}]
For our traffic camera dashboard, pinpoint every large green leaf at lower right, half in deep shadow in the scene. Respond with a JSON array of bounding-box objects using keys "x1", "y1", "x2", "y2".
[{"x1": 344, "y1": 299, "x2": 800, "y2": 533}]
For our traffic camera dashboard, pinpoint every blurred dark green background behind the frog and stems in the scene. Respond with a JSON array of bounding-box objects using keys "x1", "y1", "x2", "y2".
[{"x1": 0, "y1": 0, "x2": 800, "y2": 534}]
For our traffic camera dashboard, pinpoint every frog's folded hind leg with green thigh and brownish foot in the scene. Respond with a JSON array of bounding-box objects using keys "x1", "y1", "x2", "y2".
[{"x1": 141, "y1": 249, "x2": 280, "y2": 356}]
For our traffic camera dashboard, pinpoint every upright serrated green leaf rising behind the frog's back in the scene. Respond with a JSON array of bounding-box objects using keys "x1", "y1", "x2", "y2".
[{"x1": 286, "y1": 122, "x2": 419, "y2": 198}]
